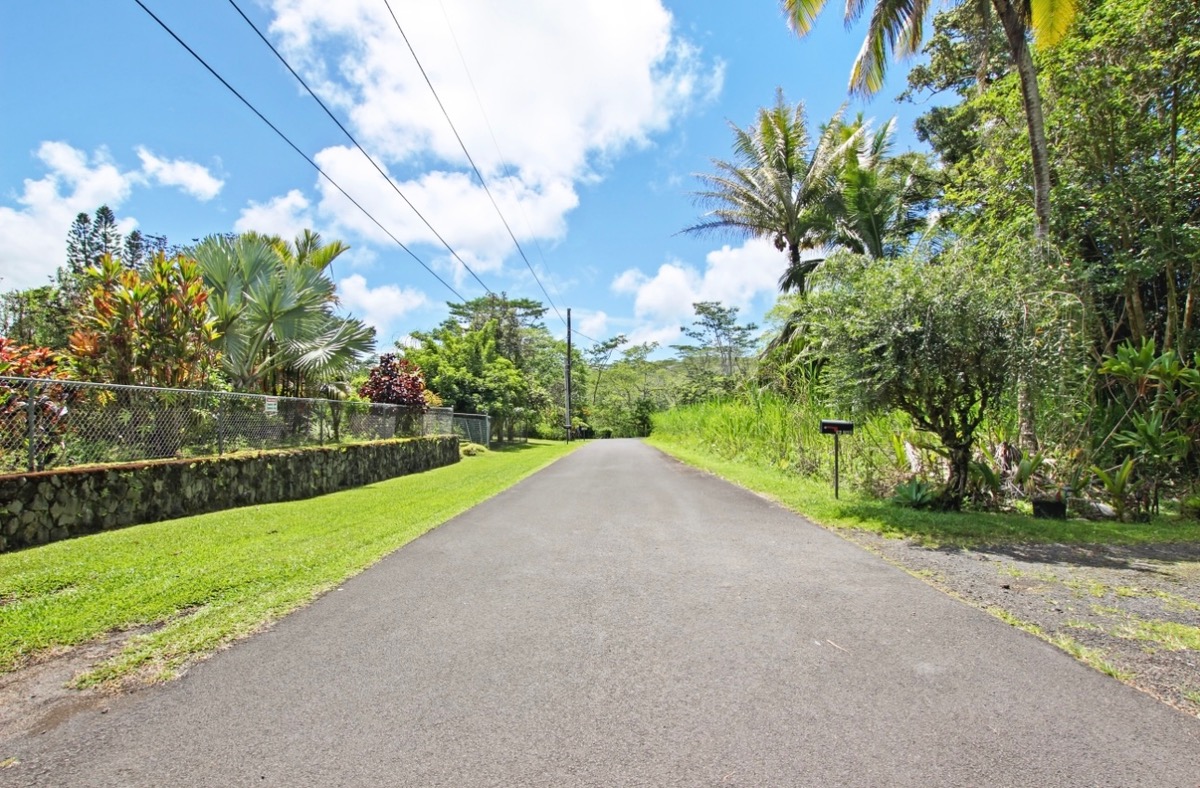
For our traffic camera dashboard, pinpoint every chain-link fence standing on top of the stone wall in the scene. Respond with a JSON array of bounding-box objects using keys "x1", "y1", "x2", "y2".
[{"x1": 0, "y1": 377, "x2": 456, "y2": 473}]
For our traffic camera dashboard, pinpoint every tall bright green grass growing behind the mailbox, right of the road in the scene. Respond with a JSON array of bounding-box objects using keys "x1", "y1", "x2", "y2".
[{"x1": 654, "y1": 391, "x2": 911, "y2": 489}]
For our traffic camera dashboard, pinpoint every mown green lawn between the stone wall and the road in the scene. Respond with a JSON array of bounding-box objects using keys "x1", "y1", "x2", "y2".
[{"x1": 0, "y1": 441, "x2": 580, "y2": 685}]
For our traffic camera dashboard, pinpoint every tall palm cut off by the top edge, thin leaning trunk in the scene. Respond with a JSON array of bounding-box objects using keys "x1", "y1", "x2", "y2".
[{"x1": 784, "y1": 0, "x2": 1075, "y2": 240}]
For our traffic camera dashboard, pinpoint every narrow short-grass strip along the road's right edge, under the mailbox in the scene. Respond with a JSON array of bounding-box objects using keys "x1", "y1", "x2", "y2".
[{"x1": 647, "y1": 435, "x2": 1200, "y2": 546}]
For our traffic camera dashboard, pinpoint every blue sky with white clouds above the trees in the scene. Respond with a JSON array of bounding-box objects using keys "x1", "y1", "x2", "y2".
[{"x1": 0, "y1": 0, "x2": 926, "y2": 351}]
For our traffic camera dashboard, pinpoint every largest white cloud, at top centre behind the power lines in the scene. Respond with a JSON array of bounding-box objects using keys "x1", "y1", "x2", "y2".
[{"x1": 264, "y1": 0, "x2": 724, "y2": 272}]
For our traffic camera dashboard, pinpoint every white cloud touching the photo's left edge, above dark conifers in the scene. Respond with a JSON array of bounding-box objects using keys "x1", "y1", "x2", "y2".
[{"x1": 0, "y1": 142, "x2": 142, "y2": 290}]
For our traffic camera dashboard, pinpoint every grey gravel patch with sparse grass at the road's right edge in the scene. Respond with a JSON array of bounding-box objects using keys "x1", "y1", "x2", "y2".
[{"x1": 841, "y1": 531, "x2": 1200, "y2": 716}]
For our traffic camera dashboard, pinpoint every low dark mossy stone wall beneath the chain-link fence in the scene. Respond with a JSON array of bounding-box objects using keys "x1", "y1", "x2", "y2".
[{"x1": 0, "y1": 435, "x2": 458, "y2": 552}]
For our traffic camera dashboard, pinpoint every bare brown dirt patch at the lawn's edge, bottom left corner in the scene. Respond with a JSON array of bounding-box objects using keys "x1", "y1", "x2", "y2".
[{"x1": 0, "y1": 627, "x2": 150, "y2": 740}]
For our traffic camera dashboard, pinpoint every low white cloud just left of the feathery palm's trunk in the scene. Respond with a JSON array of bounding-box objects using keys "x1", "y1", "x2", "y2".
[{"x1": 612, "y1": 239, "x2": 787, "y2": 324}]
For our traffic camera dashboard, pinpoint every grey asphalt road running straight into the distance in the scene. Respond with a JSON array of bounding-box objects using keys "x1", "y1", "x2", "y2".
[{"x1": 0, "y1": 441, "x2": 1200, "y2": 788}]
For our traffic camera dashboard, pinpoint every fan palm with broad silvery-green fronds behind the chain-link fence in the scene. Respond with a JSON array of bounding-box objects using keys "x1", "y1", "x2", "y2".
[{"x1": 194, "y1": 234, "x2": 374, "y2": 393}]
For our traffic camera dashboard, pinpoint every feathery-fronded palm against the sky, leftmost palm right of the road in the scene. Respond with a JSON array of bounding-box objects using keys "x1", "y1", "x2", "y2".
[{"x1": 683, "y1": 90, "x2": 858, "y2": 293}]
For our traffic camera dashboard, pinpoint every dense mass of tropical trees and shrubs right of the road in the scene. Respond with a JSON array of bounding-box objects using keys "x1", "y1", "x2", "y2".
[{"x1": 655, "y1": 0, "x2": 1200, "y2": 518}]
